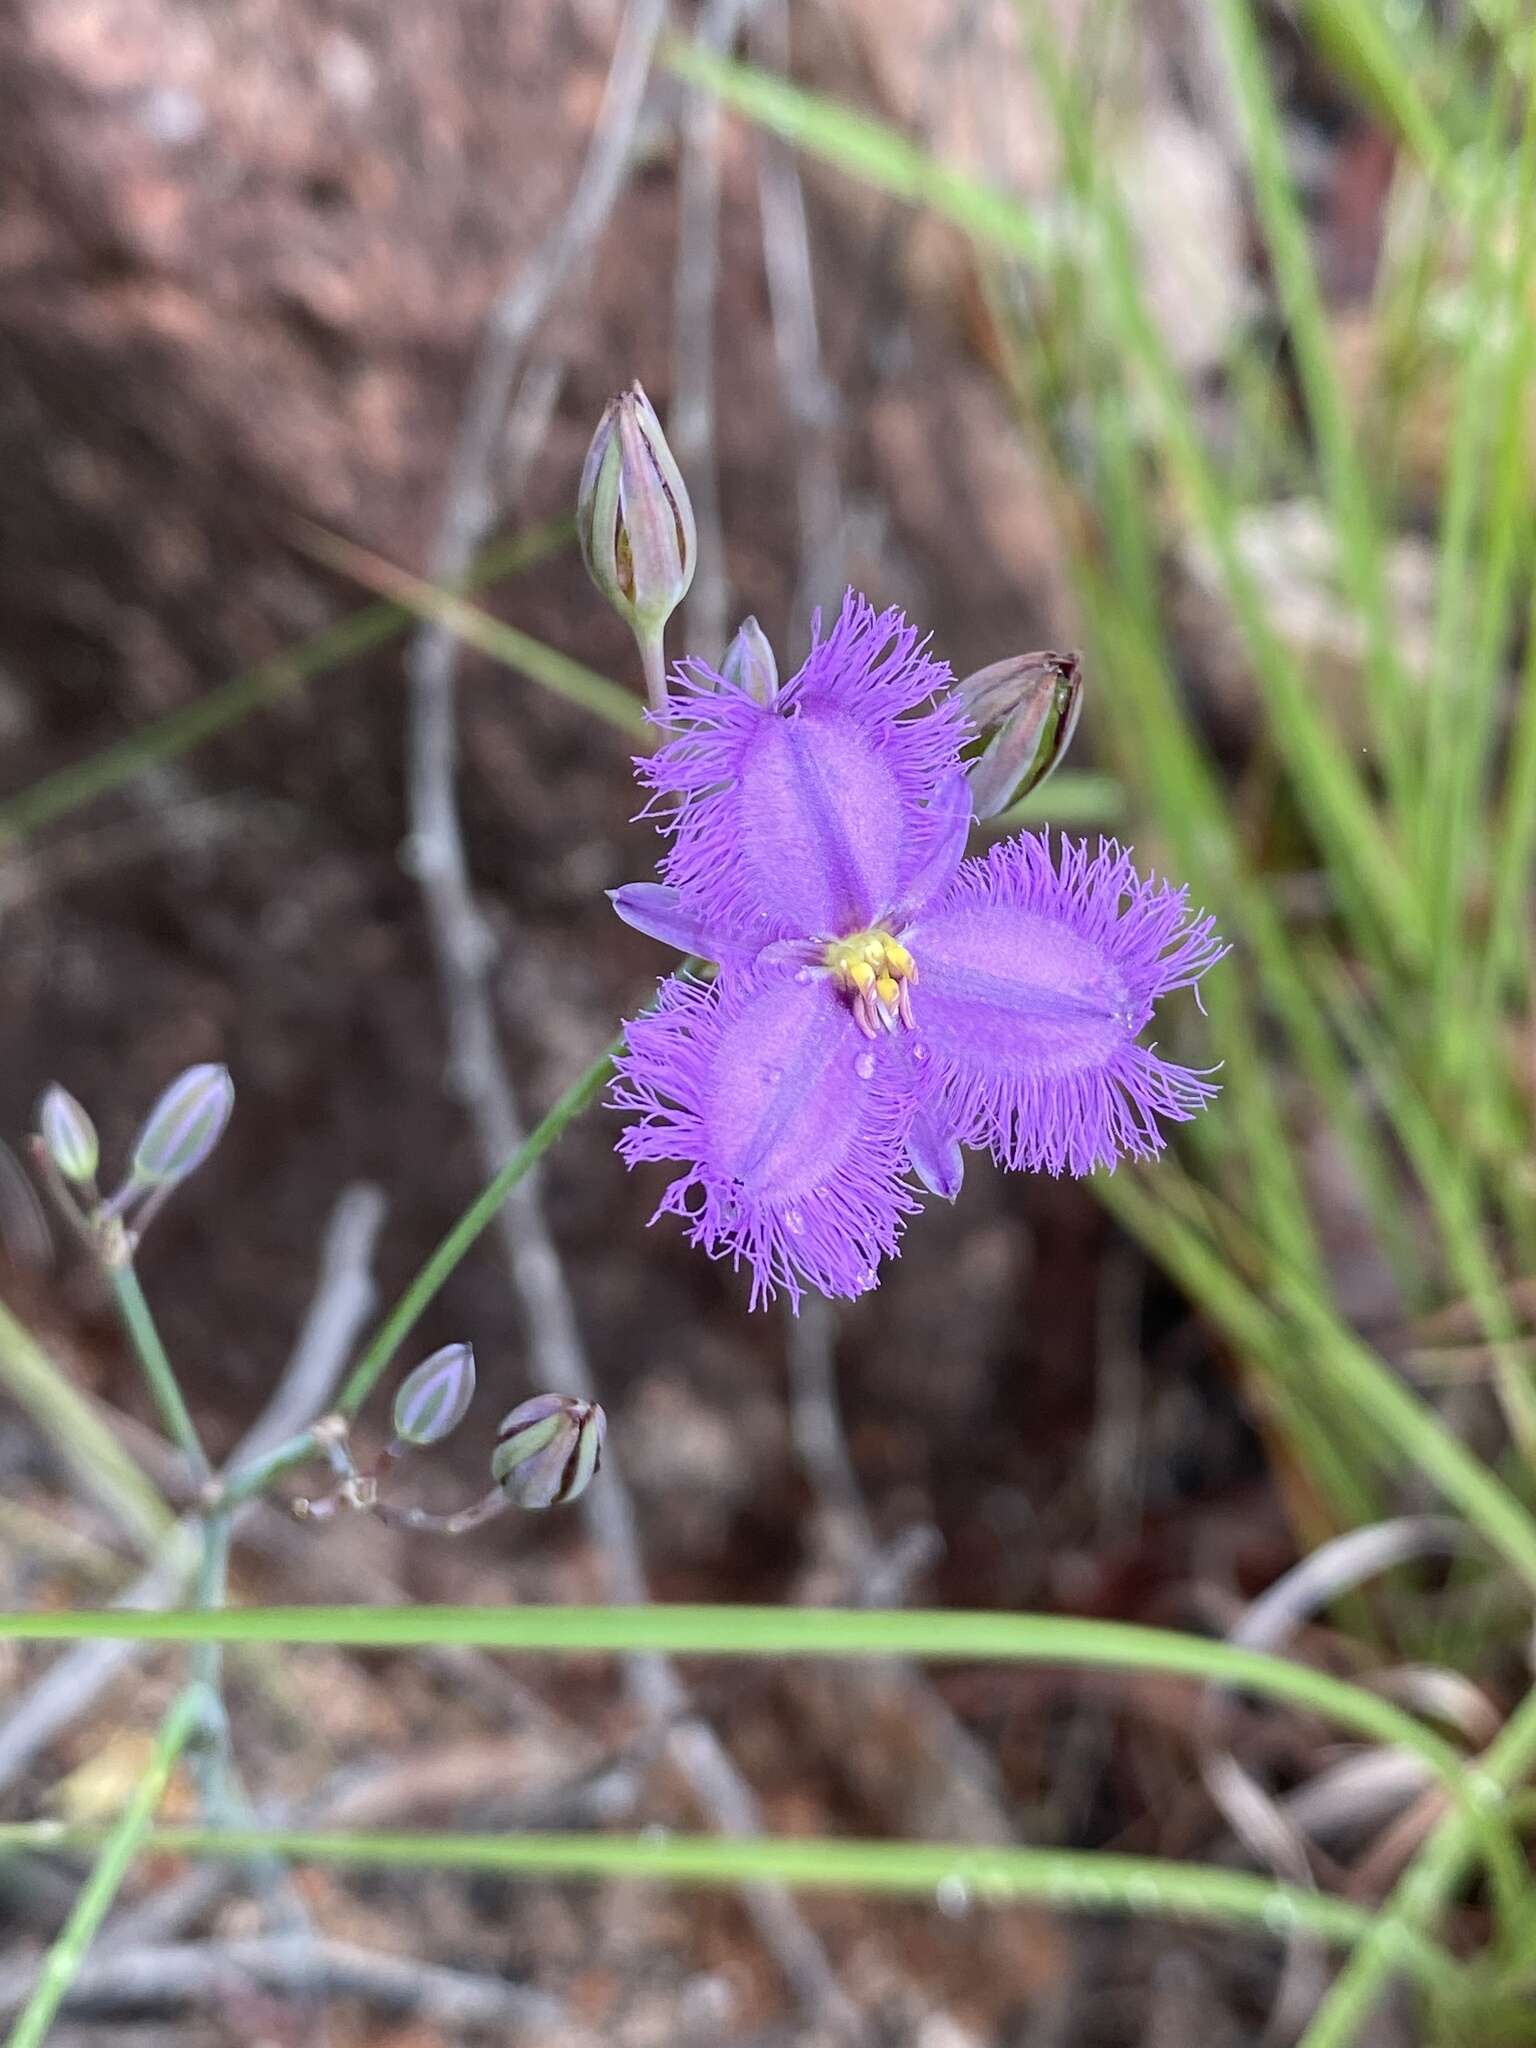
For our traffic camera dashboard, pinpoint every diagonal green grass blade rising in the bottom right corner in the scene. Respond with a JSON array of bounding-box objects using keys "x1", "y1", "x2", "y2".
[{"x1": 1298, "y1": 1690, "x2": 1536, "y2": 2048}]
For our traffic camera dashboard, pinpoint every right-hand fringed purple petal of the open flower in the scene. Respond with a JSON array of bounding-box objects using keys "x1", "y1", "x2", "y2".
[{"x1": 911, "y1": 834, "x2": 1225, "y2": 1174}]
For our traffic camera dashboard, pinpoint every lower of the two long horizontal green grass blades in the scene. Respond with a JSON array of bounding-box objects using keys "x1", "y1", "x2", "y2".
[{"x1": 0, "y1": 1823, "x2": 1460, "y2": 1989}]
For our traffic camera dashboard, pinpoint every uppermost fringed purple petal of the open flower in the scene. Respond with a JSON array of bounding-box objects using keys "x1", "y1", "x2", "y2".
[{"x1": 637, "y1": 592, "x2": 967, "y2": 942}]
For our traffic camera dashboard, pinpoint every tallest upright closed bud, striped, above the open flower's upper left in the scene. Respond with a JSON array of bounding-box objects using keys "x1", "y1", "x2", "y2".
[{"x1": 575, "y1": 385, "x2": 698, "y2": 637}]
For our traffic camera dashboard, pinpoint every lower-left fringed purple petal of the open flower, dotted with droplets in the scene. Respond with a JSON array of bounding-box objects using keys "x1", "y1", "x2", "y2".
[{"x1": 612, "y1": 975, "x2": 918, "y2": 1307}]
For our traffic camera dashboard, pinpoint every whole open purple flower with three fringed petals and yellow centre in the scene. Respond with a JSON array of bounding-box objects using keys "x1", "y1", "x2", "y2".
[{"x1": 614, "y1": 592, "x2": 1225, "y2": 1307}]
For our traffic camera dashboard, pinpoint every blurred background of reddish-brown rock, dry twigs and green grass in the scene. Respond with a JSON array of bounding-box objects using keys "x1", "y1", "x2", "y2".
[{"x1": 0, "y1": 0, "x2": 1536, "y2": 2048}]
